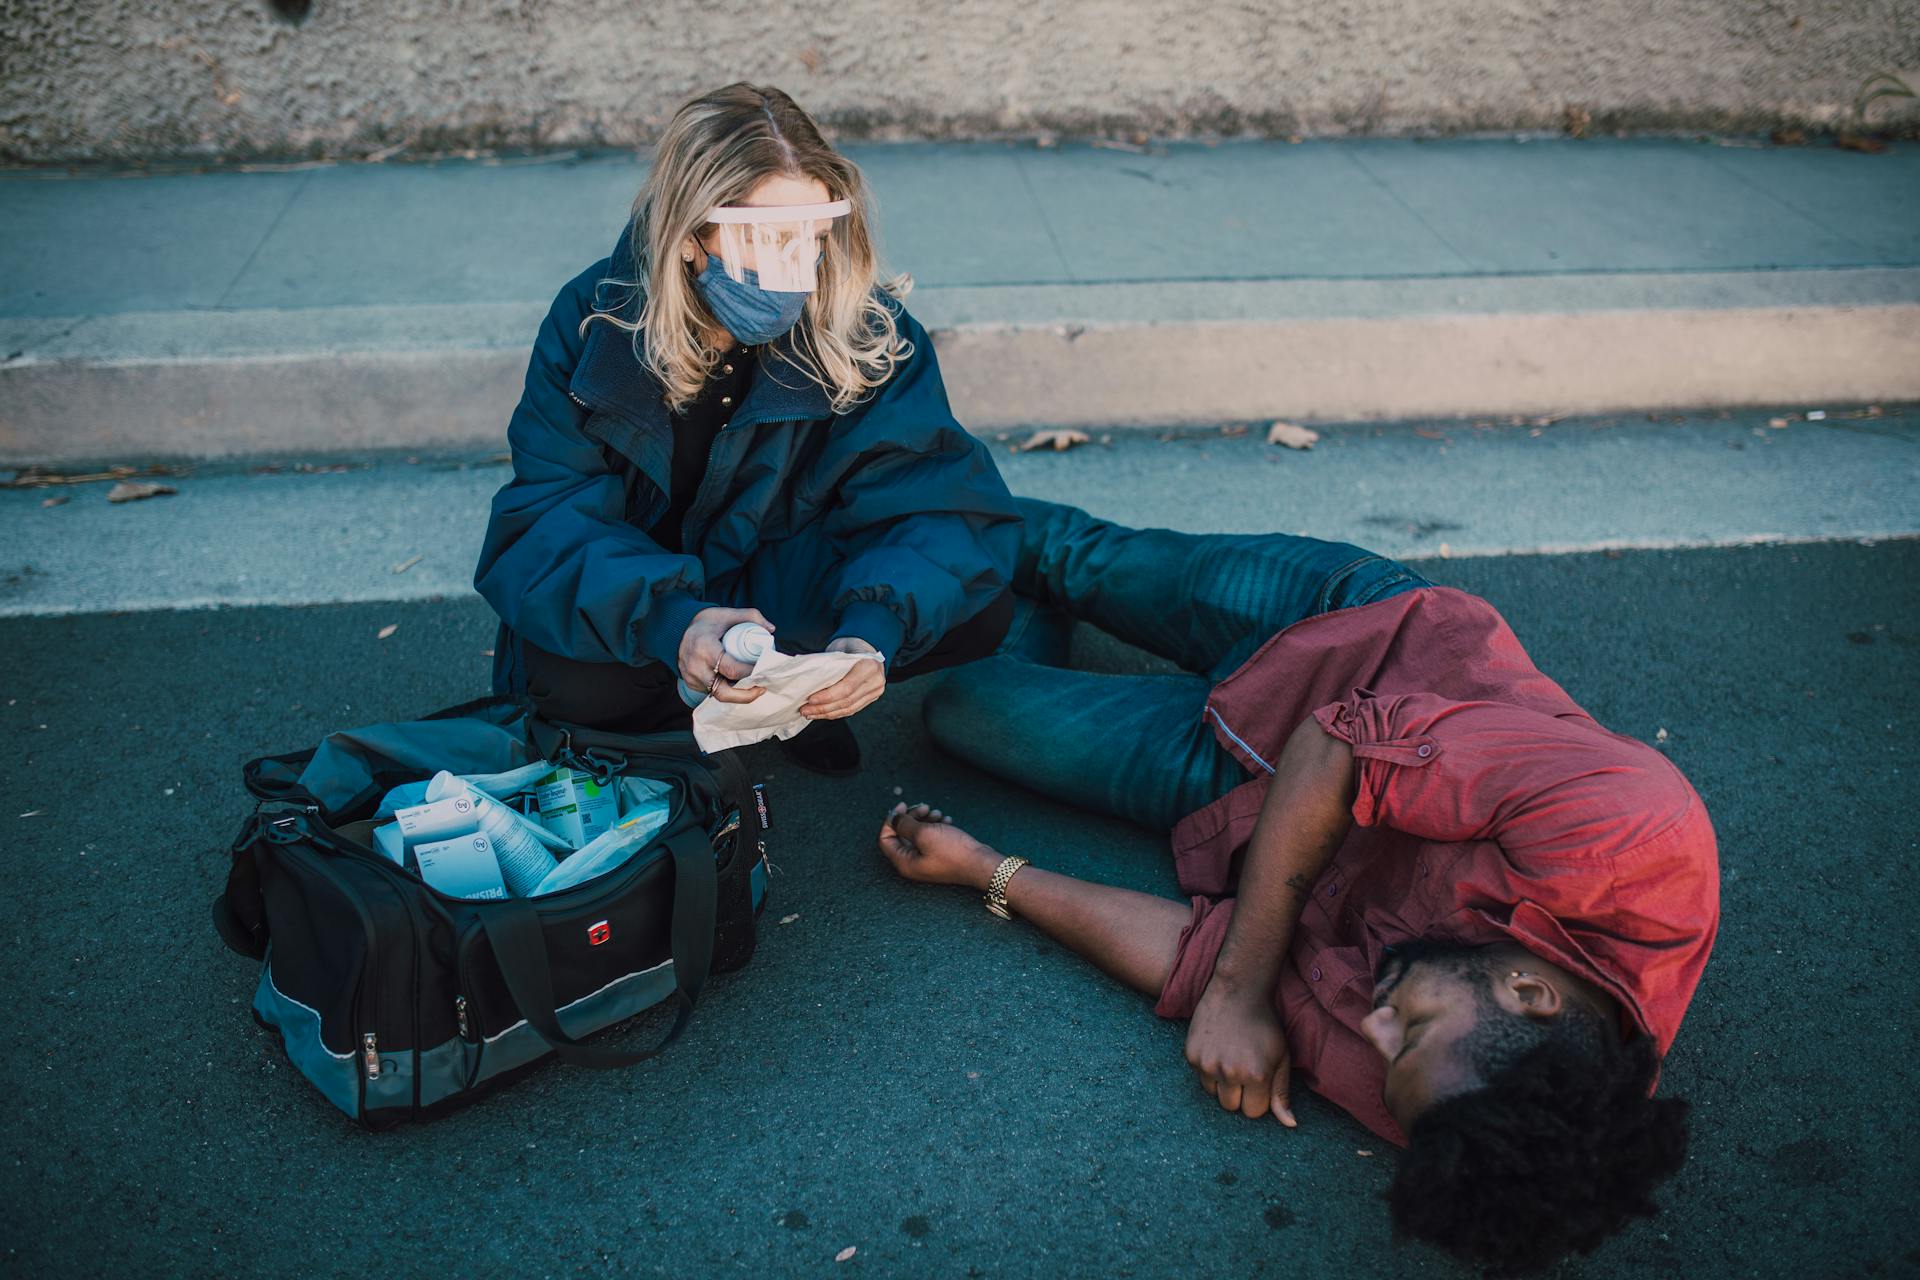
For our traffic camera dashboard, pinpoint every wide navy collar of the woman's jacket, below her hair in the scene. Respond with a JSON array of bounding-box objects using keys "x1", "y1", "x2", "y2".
[{"x1": 568, "y1": 226, "x2": 833, "y2": 435}]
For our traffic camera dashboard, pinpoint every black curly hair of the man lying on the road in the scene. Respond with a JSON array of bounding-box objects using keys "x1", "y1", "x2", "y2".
[{"x1": 1386, "y1": 994, "x2": 1688, "y2": 1276}]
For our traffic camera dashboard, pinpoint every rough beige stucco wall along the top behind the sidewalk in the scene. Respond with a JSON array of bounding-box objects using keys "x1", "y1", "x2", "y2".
[{"x1": 0, "y1": 0, "x2": 1920, "y2": 161}]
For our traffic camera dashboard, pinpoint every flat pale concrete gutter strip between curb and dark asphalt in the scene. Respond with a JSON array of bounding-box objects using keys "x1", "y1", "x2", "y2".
[{"x1": 0, "y1": 405, "x2": 1920, "y2": 618}]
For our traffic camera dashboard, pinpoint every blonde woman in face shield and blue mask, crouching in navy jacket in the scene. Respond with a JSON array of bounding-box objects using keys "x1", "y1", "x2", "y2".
[{"x1": 474, "y1": 84, "x2": 1020, "y2": 773}]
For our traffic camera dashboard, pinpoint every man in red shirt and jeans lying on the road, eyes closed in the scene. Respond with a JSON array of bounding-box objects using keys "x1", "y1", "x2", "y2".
[{"x1": 879, "y1": 501, "x2": 1718, "y2": 1270}]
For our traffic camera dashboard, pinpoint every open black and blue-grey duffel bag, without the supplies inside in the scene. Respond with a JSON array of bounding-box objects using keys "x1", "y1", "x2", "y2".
[{"x1": 213, "y1": 699, "x2": 768, "y2": 1126}]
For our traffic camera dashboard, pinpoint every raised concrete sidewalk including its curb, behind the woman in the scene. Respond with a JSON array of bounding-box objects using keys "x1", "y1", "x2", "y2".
[{"x1": 0, "y1": 140, "x2": 1920, "y2": 462}]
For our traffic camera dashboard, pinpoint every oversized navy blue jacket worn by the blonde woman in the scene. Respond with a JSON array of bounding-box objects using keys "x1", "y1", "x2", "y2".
[{"x1": 474, "y1": 234, "x2": 1020, "y2": 693}]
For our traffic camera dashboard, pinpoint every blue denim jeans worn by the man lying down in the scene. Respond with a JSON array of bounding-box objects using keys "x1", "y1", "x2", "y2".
[{"x1": 925, "y1": 499, "x2": 1430, "y2": 831}]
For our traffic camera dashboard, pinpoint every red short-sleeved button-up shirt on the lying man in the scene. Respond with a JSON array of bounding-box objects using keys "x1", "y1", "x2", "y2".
[{"x1": 1156, "y1": 587, "x2": 1720, "y2": 1142}]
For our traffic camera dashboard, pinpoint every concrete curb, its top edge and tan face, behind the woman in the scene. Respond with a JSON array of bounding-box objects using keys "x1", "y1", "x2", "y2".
[{"x1": 0, "y1": 269, "x2": 1920, "y2": 464}]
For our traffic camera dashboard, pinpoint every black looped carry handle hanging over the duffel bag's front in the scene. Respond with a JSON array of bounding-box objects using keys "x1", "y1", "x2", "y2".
[{"x1": 480, "y1": 827, "x2": 718, "y2": 1069}]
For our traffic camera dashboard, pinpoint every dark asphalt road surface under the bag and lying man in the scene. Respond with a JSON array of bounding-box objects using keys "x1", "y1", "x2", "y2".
[{"x1": 0, "y1": 541, "x2": 1920, "y2": 1278}]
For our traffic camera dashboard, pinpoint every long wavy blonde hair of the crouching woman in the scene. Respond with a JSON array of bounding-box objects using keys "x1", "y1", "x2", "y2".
[{"x1": 580, "y1": 83, "x2": 914, "y2": 413}]
